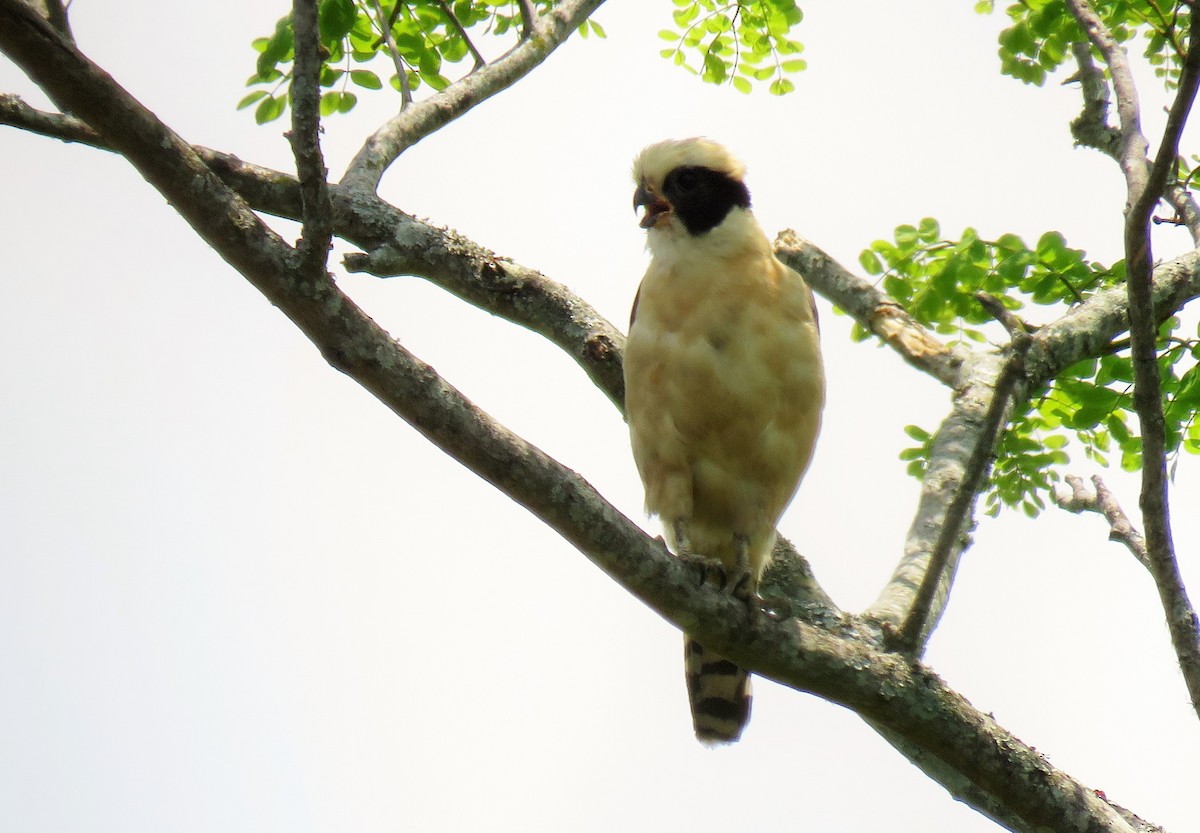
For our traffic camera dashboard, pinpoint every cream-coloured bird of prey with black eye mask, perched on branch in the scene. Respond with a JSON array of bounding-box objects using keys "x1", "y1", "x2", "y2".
[{"x1": 624, "y1": 137, "x2": 826, "y2": 745}]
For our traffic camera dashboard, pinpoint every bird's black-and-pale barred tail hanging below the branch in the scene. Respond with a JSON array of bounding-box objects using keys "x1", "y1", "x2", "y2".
[{"x1": 684, "y1": 634, "x2": 751, "y2": 744}]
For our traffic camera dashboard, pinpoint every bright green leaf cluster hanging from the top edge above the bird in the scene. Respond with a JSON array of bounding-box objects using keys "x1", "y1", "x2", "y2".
[{"x1": 659, "y1": 0, "x2": 806, "y2": 95}]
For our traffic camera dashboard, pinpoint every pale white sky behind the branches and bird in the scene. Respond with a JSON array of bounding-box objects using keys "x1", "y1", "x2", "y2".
[{"x1": 0, "y1": 0, "x2": 1200, "y2": 833}]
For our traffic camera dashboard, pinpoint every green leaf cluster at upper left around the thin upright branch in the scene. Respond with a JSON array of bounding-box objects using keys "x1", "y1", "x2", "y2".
[{"x1": 238, "y1": 0, "x2": 568, "y2": 124}]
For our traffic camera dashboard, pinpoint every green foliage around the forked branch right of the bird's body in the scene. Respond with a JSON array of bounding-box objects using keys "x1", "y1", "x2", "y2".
[{"x1": 853, "y1": 217, "x2": 1200, "y2": 516}]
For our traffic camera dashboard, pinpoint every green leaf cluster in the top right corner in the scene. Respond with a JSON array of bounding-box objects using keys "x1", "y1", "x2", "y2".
[{"x1": 976, "y1": 0, "x2": 1190, "y2": 89}]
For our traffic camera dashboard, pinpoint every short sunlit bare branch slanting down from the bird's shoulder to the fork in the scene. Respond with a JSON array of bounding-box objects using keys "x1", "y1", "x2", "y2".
[{"x1": 775, "y1": 229, "x2": 966, "y2": 388}]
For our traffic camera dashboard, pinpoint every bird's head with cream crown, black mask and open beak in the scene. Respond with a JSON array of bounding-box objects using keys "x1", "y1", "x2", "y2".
[{"x1": 634, "y1": 138, "x2": 750, "y2": 236}]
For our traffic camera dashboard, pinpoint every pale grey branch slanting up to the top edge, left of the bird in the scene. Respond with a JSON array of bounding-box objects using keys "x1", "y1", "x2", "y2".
[{"x1": 342, "y1": 0, "x2": 604, "y2": 191}]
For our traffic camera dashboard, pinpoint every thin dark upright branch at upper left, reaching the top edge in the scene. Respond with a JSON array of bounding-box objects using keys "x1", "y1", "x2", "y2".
[{"x1": 288, "y1": 0, "x2": 334, "y2": 274}]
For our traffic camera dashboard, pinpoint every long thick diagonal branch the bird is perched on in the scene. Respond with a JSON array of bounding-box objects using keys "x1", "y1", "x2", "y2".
[{"x1": 0, "y1": 6, "x2": 1180, "y2": 833}]
